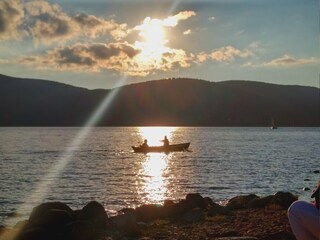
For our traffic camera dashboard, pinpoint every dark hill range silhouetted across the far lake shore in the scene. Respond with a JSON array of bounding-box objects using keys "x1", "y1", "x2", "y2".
[{"x1": 0, "y1": 75, "x2": 320, "y2": 126}]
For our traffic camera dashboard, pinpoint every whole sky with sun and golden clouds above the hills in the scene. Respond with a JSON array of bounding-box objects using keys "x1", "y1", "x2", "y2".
[{"x1": 0, "y1": 0, "x2": 320, "y2": 89}]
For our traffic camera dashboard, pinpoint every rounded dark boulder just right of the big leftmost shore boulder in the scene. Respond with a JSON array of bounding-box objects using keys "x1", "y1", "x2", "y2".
[{"x1": 79, "y1": 201, "x2": 108, "y2": 228}]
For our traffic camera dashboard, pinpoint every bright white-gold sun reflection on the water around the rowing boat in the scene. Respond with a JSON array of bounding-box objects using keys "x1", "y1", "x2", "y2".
[{"x1": 137, "y1": 127, "x2": 177, "y2": 203}]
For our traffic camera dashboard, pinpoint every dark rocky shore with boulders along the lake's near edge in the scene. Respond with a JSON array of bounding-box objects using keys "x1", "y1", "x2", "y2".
[{"x1": 0, "y1": 192, "x2": 297, "y2": 240}]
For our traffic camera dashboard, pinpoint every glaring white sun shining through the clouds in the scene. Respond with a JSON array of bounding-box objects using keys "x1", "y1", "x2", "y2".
[{"x1": 135, "y1": 17, "x2": 168, "y2": 64}]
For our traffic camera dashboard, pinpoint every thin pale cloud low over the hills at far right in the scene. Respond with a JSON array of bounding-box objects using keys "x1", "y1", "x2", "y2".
[{"x1": 263, "y1": 54, "x2": 319, "y2": 67}]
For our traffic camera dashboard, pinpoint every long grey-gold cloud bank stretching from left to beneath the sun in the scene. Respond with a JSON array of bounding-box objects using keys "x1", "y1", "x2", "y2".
[{"x1": 14, "y1": 42, "x2": 192, "y2": 76}]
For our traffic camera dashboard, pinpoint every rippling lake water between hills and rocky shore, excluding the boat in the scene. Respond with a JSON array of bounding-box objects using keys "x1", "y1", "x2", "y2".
[{"x1": 0, "y1": 127, "x2": 320, "y2": 225}]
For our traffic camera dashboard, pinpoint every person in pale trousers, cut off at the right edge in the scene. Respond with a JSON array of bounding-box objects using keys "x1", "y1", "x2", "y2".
[{"x1": 288, "y1": 181, "x2": 320, "y2": 240}]
